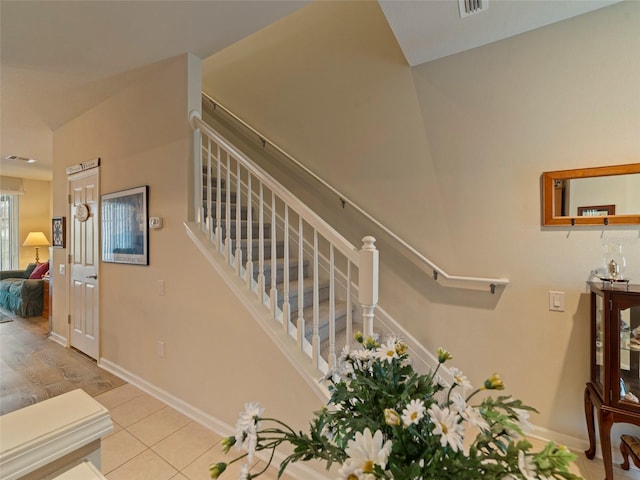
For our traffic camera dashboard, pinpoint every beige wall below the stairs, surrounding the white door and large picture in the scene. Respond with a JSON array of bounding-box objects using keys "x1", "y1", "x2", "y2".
[{"x1": 53, "y1": 55, "x2": 320, "y2": 442}]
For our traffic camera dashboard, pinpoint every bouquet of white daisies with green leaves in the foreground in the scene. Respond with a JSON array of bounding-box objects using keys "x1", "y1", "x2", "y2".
[{"x1": 209, "y1": 333, "x2": 580, "y2": 480}]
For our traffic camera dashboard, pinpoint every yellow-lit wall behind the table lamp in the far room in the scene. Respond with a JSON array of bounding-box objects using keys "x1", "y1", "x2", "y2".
[{"x1": 18, "y1": 178, "x2": 51, "y2": 268}]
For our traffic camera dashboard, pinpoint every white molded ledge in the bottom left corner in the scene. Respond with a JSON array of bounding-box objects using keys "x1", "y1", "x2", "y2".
[{"x1": 0, "y1": 389, "x2": 113, "y2": 480}]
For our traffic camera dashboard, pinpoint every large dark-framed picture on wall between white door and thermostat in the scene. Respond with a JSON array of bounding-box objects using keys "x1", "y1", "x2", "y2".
[{"x1": 100, "y1": 185, "x2": 149, "y2": 265}]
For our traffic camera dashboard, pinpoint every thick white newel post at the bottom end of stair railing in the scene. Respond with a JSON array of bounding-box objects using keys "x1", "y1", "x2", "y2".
[{"x1": 358, "y1": 237, "x2": 378, "y2": 336}]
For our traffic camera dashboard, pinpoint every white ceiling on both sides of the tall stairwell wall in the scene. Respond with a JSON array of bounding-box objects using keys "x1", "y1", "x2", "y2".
[{"x1": 0, "y1": 0, "x2": 620, "y2": 179}]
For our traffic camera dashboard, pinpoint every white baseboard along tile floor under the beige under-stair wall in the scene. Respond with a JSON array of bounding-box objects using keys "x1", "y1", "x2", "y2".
[{"x1": 98, "y1": 358, "x2": 333, "y2": 480}]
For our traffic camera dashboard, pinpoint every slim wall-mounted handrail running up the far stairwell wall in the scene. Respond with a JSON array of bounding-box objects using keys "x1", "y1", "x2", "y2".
[{"x1": 202, "y1": 92, "x2": 509, "y2": 293}]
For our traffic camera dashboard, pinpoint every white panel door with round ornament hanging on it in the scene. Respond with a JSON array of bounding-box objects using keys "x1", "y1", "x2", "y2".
[{"x1": 69, "y1": 169, "x2": 100, "y2": 360}]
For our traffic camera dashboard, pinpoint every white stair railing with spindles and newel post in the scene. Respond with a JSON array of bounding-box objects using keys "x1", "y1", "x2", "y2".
[{"x1": 190, "y1": 112, "x2": 378, "y2": 372}]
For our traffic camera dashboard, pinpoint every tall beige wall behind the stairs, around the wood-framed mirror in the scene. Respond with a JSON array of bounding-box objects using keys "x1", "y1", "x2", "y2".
[{"x1": 203, "y1": 2, "x2": 640, "y2": 446}]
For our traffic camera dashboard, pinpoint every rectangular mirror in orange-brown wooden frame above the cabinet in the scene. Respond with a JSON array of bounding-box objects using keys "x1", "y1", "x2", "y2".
[{"x1": 542, "y1": 163, "x2": 640, "y2": 226}]
